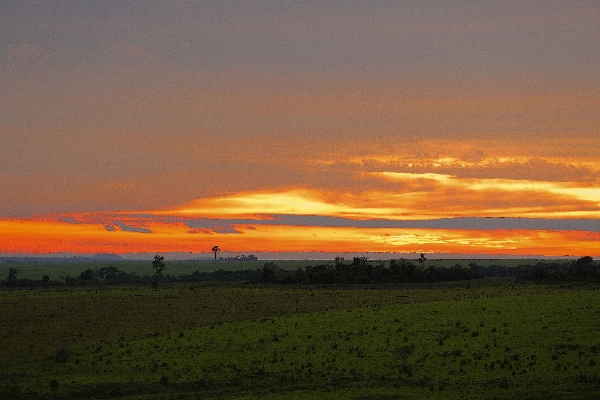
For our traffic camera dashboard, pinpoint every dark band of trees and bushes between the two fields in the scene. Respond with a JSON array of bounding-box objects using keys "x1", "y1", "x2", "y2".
[{"x1": 0, "y1": 256, "x2": 600, "y2": 288}]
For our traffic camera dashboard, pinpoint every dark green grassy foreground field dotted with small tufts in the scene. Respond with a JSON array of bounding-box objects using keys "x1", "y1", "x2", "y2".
[{"x1": 0, "y1": 279, "x2": 600, "y2": 399}]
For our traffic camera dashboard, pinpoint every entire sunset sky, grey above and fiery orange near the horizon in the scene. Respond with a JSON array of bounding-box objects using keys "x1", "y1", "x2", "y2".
[{"x1": 0, "y1": 0, "x2": 600, "y2": 257}]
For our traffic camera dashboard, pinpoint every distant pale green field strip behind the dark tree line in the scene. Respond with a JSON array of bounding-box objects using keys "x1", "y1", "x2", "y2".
[{"x1": 0, "y1": 259, "x2": 573, "y2": 281}]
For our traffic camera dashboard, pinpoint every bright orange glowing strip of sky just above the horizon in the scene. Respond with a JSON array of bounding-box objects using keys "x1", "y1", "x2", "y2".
[{"x1": 0, "y1": 216, "x2": 600, "y2": 256}]
